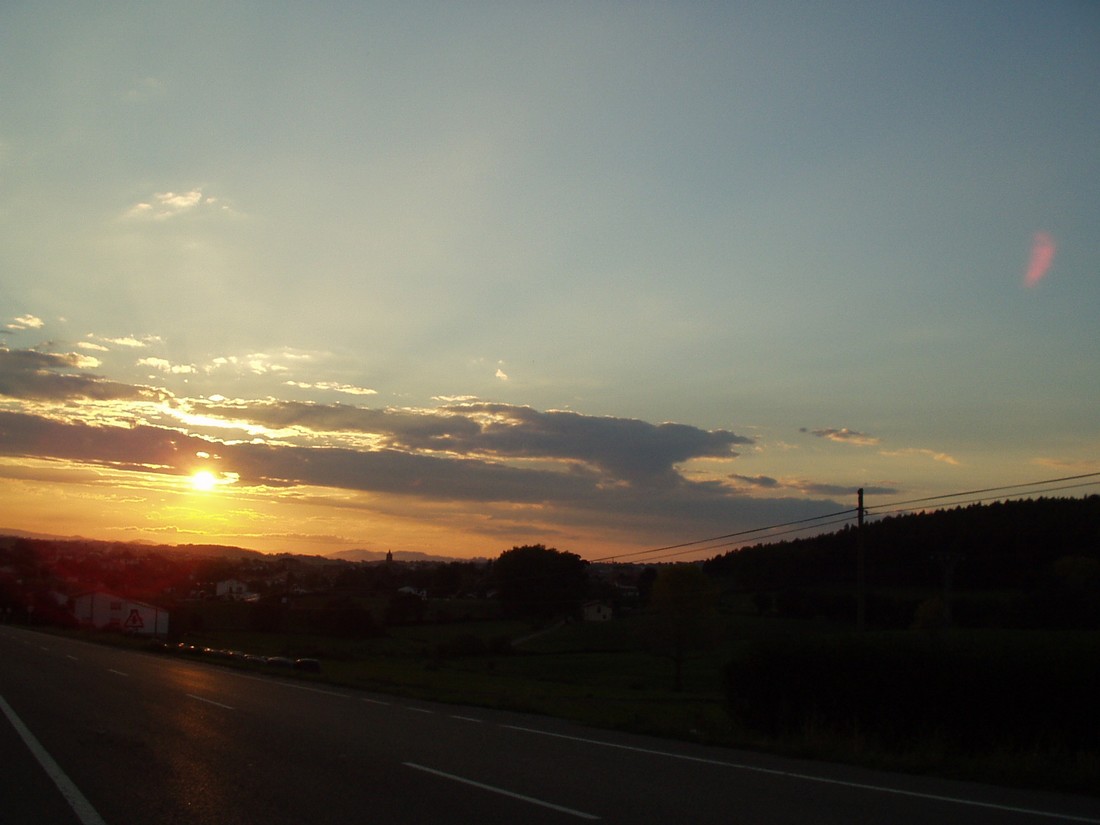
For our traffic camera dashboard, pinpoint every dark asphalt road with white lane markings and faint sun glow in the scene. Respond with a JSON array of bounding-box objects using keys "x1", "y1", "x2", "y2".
[{"x1": 0, "y1": 626, "x2": 1100, "y2": 825}]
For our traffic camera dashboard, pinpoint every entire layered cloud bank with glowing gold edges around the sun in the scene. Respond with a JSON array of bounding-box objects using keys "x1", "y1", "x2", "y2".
[{"x1": 0, "y1": 350, "x2": 858, "y2": 552}]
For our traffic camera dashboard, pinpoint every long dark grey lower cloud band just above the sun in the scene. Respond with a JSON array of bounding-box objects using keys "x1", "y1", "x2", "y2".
[{"x1": 0, "y1": 410, "x2": 838, "y2": 550}]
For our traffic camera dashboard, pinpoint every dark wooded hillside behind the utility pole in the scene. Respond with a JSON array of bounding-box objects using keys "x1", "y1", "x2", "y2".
[{"x1": 703, "y1": 495, "x2": 1100, "y2": 628}]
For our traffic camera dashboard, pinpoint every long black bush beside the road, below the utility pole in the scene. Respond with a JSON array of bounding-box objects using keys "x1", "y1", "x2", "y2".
[{"x1": 725, "y1": 634, "x2": 1100, "y2": 754}]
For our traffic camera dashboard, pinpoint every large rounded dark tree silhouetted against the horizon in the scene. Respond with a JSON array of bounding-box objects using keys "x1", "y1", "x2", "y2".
[{"x1": 493, "y1": 545, "x2": 589, "y2": 622}]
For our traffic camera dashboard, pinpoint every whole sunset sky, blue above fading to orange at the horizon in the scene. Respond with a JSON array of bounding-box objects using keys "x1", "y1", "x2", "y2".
[{"x1": 0, "y1": 0, "x2": 1100, "y2": 560}]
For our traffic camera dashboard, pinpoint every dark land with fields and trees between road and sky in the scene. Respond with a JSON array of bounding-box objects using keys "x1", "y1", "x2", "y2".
[{"x1": 0, "y1": 496, "x2": 1100, "y2": 793}]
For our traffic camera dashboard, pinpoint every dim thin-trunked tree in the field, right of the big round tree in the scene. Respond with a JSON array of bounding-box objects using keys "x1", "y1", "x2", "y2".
[{"x1": 649, "y1": 564, "x2": 717, "y2": 691}]
